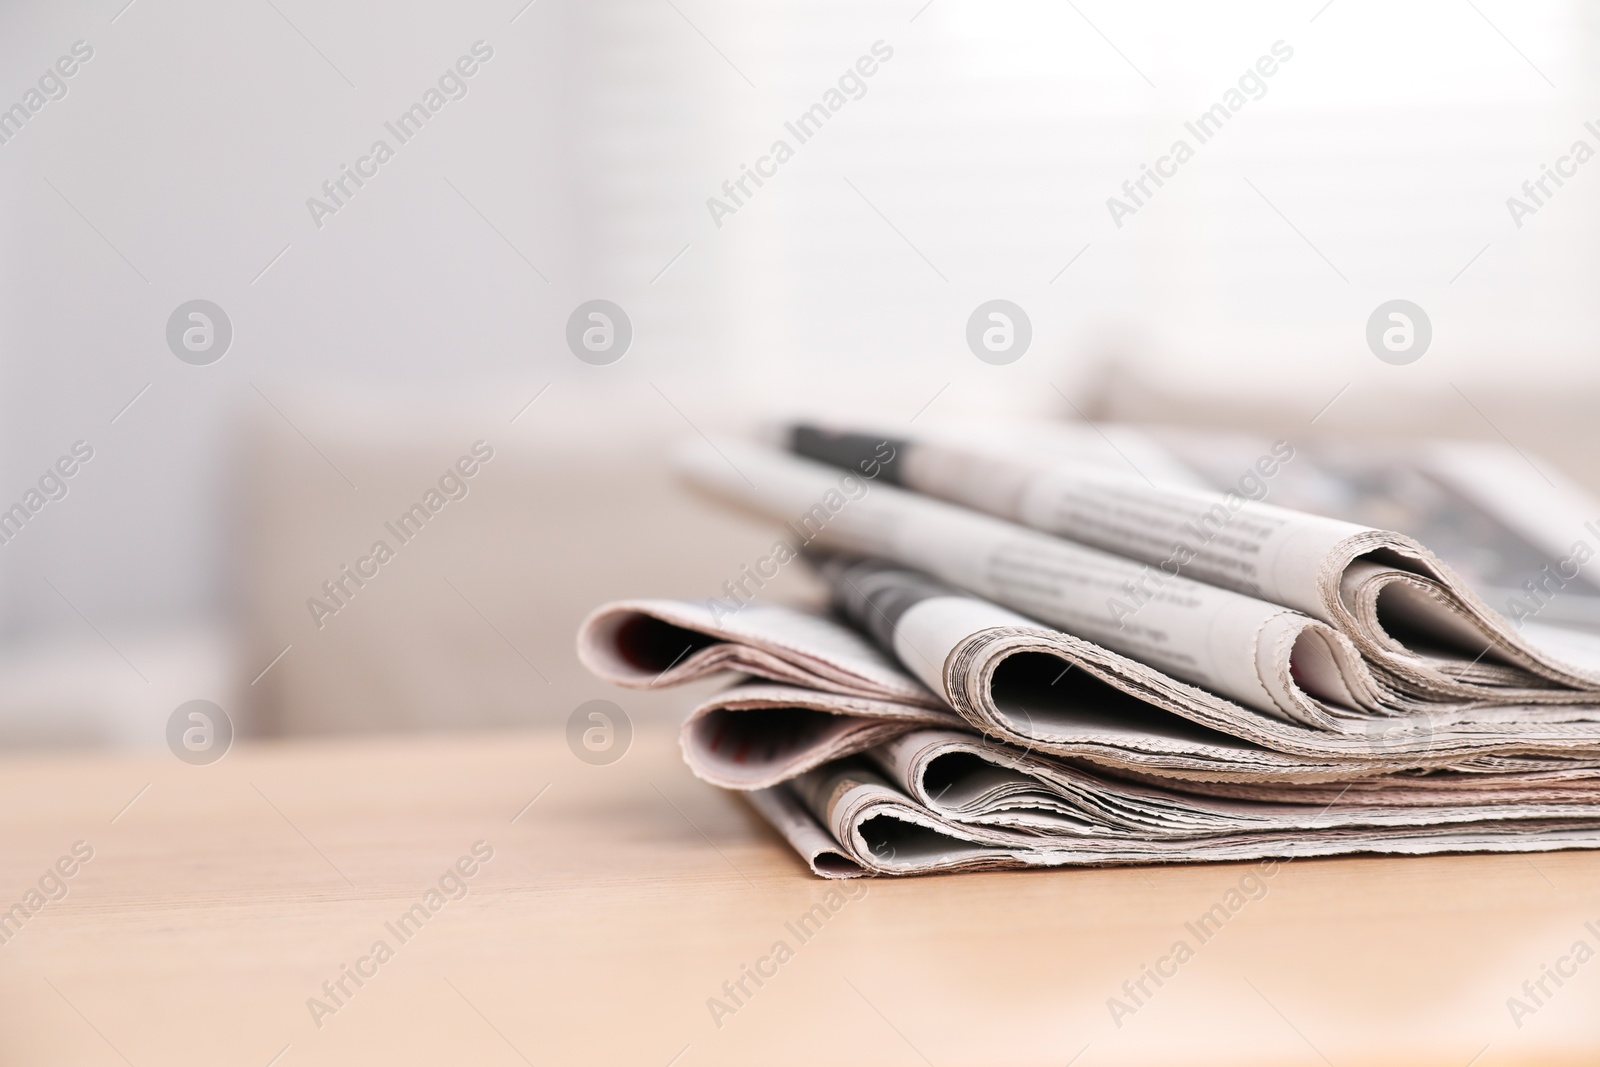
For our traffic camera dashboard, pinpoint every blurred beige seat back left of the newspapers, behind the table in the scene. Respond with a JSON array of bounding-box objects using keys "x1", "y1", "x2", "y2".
[{"x1": 235, "y1": 386, "x2": 814, "y2": 734}]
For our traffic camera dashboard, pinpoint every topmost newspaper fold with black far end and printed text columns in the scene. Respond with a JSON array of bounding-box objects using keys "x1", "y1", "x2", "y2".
[{"x1": 790, "y1": 426, "x2": 1600, "y2": 705}]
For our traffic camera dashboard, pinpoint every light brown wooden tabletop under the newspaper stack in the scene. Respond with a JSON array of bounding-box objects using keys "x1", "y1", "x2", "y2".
[{"x1": 9, "y1": 731, "x2": 1600, "y2": 1067}]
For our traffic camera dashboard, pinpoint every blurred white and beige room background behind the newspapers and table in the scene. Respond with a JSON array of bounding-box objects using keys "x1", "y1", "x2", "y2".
[{"x1": 0, "y1": 0, "x2": 1600, "y2": 745}]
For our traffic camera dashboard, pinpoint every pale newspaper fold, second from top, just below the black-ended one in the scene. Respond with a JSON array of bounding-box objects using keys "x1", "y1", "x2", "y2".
[{"x1": 678, "y1": 442, "x2": 1403, "y2": 728}]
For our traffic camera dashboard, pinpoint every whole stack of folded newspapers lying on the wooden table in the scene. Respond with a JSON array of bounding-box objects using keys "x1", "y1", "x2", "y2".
[{"x1": 578, "y1": 426, "x2": 1600, "y2": 877}]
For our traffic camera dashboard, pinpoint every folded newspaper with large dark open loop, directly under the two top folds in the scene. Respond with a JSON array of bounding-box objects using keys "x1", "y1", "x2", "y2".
[{"x1": 818, "y1": 558, "x2": 1600, "y2": 781}]
